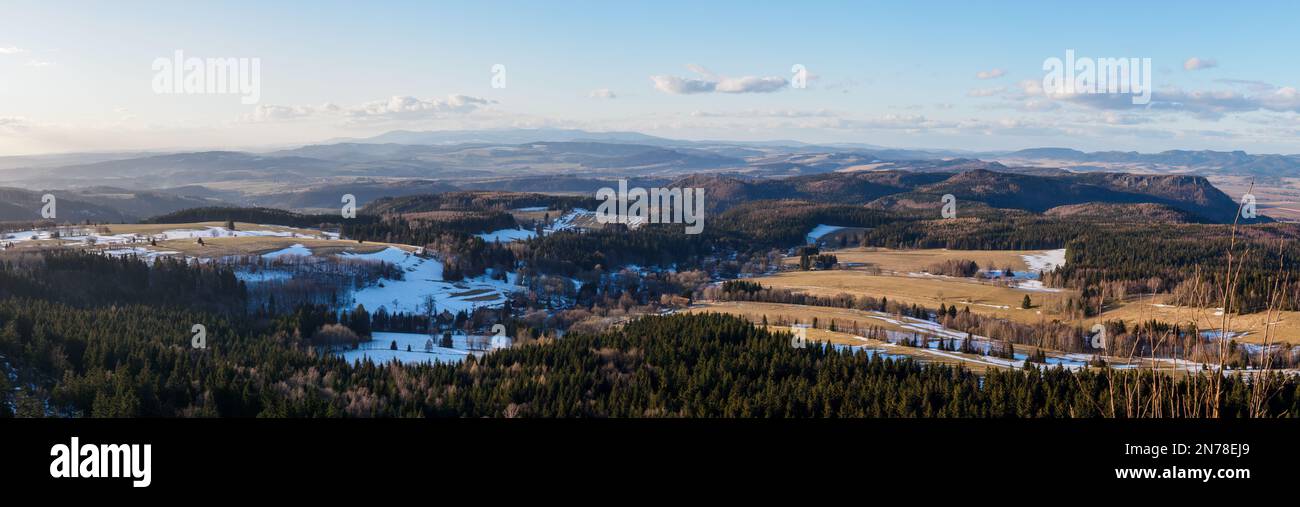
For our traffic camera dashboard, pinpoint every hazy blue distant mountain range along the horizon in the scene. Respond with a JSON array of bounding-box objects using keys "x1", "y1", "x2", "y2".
[{"x1": 0, "y1": 129, "x2": 1300, "y2": 221}]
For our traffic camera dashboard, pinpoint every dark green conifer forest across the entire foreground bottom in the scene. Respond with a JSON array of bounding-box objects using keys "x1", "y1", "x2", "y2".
[{"x1": 0, "y1": 284, "x2": 1300, "y2": 417}]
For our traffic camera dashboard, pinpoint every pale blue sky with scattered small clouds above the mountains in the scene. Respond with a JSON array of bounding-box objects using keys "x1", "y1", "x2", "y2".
[{"x1": 0, "y1": 0, "x2": 1300, "y2": 156}]
